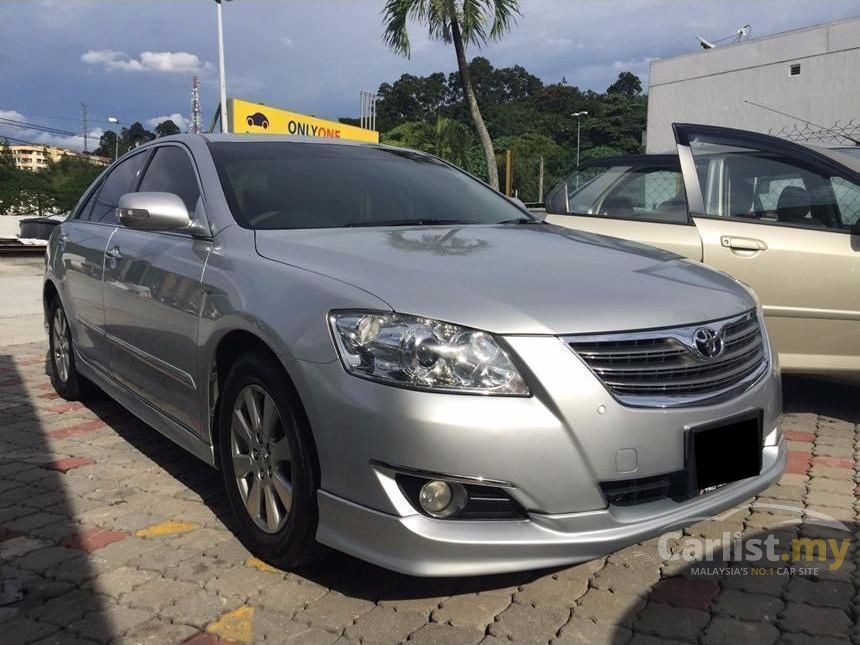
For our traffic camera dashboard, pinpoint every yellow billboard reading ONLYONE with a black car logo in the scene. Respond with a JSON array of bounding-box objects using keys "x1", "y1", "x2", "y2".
[{"x1": 227, "y1": 99, "x2": 379, "y2": 143}]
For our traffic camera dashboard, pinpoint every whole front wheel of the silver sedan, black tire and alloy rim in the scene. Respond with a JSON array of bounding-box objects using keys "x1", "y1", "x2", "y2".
[{"x1": 217, "y1": 354, "x2": 318, "y2": 569}]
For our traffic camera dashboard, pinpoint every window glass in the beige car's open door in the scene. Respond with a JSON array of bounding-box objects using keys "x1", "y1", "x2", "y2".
[{"x1": 690, "y1": 138, "x2": 860, "y2": 231}]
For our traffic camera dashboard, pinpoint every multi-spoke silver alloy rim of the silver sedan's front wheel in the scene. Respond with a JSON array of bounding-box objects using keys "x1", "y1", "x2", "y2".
[{"x1": 230, "y1": 385, "x2": 293, "y2": 534}]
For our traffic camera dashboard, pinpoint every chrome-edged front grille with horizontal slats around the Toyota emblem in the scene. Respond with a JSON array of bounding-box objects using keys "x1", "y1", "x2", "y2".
[{"x1": 565, "y1": 311, "x2": 767, "y2": 407}]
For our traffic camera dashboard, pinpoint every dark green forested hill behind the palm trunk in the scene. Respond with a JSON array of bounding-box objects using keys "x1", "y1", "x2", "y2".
[{"x1": 341, "y1": 57, "x2": 647, "y2": 201}]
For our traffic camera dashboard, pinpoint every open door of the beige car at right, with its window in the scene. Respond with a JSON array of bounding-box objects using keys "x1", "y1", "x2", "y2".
[{"x1": 675, "y1": 125, "x2": 860, "y2": 373}]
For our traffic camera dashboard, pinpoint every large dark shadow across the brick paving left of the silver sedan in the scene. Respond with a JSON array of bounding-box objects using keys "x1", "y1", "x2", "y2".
[{"x1": 0, "y1": 350, "x2": 114, "y2": 642}]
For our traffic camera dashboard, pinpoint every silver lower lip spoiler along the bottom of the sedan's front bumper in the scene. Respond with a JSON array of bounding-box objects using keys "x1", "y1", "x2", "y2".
[{"x1": 317, "y1": 441, "x2": 786, "y2": 576}]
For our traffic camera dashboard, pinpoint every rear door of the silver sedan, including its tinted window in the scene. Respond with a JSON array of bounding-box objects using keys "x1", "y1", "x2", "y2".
[{"x1": 57, "y1": 153, "x2": 146, "y2": 368}]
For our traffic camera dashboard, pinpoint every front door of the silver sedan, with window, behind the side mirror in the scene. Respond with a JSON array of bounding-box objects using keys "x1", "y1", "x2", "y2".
[{"x1": 104, "y1": 145, "x2": 212, "y2": 432}]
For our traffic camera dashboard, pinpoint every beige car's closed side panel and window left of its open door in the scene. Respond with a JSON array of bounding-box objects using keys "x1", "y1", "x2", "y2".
[{"x1": 546, "y1": 155, "x2": 702, "y2": 261}]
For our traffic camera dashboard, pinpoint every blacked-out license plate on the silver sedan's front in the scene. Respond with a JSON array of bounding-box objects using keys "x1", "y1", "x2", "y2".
[{"x1": 686, "y1": 411, "x2": 763, "y2": 495}]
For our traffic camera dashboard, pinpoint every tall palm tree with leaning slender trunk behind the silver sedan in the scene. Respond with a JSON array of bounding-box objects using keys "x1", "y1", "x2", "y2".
[{"x1": 382, "y1": 0, "x2": 520, "y2": 190}]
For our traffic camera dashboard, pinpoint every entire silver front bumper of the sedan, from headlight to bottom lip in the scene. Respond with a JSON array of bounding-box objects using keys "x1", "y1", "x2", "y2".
[{"x1": 283, "y1": 337, "x2": 785, "y2": 576}]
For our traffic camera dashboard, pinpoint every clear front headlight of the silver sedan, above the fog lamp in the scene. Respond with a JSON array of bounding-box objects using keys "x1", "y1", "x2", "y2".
[{"x1": 329, "y1": 311, "x2": 530, "y2": 396}]
